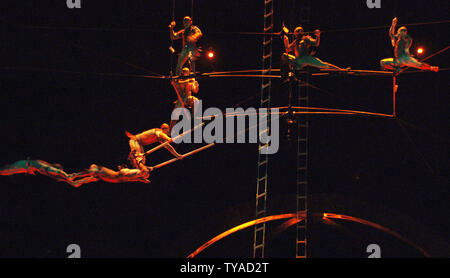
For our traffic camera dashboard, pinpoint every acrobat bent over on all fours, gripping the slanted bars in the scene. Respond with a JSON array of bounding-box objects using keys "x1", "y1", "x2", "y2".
[{"x1": 125, "y1": 124, "x2": 183, "y2": 169}]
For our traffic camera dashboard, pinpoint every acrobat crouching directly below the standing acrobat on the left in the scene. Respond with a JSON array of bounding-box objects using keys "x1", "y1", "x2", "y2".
[{"x1": 169, "y1": 68, "x2": 199, "y2": 130}]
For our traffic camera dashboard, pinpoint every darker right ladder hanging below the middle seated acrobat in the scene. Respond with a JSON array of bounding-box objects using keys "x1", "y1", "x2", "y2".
[{"x1": 295, "y1": 0, "x2": 311, "y2": 258}]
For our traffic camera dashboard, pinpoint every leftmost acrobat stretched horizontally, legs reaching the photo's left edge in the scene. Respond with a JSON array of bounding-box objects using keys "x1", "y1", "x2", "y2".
[{"x1": 0, "y1": 159, "x2": 73, "y2": 184}]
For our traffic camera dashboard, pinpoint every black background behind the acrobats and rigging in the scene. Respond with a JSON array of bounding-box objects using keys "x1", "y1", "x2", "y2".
[{"x1": 0, "y1": 0, "x2": 450, "y2": 258}]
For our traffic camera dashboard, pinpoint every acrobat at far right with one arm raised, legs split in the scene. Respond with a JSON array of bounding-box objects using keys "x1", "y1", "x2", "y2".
[{"x1": 380, "y1": 17, "x2": 439, "y2": 75}]
